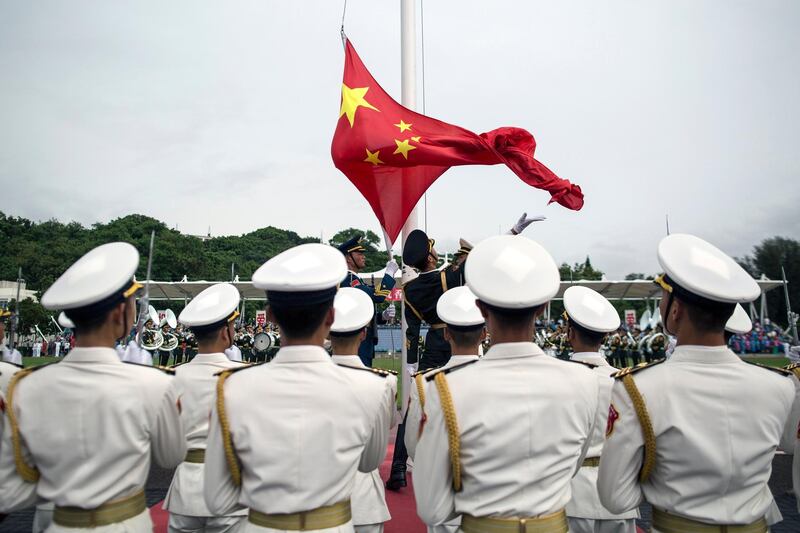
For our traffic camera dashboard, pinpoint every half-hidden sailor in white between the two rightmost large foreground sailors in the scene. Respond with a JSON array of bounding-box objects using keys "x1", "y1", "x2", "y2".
[{"x1": 564, "y1": 286, "x2": 639, "y2": 533}]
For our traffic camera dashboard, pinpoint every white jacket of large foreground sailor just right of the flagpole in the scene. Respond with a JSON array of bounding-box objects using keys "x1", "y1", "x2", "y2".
[{"x1": 414, "y1": 342, "x2": 598, "y2": 526}]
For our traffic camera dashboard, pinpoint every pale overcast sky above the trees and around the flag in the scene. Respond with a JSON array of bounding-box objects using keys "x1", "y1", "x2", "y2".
[{"x1": 0, "y1": 0, "x2": 800, "y2": 278}]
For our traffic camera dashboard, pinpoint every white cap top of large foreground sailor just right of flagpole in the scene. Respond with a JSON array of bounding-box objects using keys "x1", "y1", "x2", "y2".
[{"x1": 465, "y1": 235, "x2": 561, "y2": 309}]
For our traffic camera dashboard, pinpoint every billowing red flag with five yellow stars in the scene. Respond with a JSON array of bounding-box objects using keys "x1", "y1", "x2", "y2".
[{"x1": 331, "y1": 40, "x2": 583, "y2": 241}]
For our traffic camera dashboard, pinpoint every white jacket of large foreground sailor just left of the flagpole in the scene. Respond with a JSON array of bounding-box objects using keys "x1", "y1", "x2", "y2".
[{"x1": 205, "y1": 346, "x2": 395, "y2": 524}]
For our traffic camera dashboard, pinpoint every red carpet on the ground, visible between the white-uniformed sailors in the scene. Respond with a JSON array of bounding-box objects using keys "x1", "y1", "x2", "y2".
[{"x1": 150, "y1": 431, "x2": 644, "y2": 533}]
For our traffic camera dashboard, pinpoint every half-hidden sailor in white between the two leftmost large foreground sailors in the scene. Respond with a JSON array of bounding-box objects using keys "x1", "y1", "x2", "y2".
[{"x1": 164, "y1": 283, "x2": 246, "y2": 533}]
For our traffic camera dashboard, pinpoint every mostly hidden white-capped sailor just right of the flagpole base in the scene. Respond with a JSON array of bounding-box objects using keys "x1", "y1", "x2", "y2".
[{"x1": 404, "y1": 286, "x2": 486, "y2": 533}]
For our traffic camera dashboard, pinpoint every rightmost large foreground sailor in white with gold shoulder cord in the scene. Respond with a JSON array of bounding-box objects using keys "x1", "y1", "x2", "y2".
[{"x1": 598, "y1": 234, "x2": 794, "y2": 533}]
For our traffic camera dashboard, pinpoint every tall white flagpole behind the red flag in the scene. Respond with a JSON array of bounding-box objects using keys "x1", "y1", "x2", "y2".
[{"x1": 400, "y1": 0, "x2": 417, "y2": 409}]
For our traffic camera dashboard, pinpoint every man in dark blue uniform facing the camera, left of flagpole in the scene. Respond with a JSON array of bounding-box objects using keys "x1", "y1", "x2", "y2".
[{"x1": 337, "y1": 235, "x2": 399, "y2": 366}]
